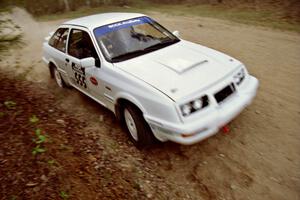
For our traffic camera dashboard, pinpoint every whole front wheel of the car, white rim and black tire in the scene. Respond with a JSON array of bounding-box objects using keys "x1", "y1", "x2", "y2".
[{"x1": 123, "y1": 105, "x2": 156, "y2": 148}]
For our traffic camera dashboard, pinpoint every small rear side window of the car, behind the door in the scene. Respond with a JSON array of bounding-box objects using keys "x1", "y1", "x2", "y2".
[{"x1": 49, "y1": 28, "x2": 69, "y2": 52}]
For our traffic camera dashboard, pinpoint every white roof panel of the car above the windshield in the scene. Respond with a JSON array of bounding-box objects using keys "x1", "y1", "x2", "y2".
[{"x1": 63, "y1": 12, "x2": 145, "y2": 30}]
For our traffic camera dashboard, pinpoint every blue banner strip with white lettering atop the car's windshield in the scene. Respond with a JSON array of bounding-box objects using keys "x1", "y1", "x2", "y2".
[{"x1": 94, "y1": 17, "x2": 152, "y2": 37}]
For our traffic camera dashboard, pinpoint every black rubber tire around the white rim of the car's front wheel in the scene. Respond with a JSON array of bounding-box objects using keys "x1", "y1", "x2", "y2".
[{"x1": 122, "y1": 104, "x2": 157, "y2": 149}]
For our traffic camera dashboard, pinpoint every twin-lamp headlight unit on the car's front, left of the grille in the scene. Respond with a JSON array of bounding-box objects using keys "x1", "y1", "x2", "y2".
[{"x1": 180, "y1": 95, "x2": 208, "y2": 116}]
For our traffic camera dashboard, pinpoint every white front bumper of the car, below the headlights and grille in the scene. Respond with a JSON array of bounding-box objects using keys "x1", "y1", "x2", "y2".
[{"x1": 145, "y1": 76, "x2": 259, "y2": 145}]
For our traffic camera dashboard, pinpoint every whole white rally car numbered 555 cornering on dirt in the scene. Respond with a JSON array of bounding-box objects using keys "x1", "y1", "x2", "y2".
[{"x1": 43, "y1": 13, "x2": 259, "y2": 146}]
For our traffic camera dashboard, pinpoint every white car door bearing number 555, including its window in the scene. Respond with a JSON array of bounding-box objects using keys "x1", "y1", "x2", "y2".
[{"x1": 65, "y1": 28, "x2": 105, "y2": 105}]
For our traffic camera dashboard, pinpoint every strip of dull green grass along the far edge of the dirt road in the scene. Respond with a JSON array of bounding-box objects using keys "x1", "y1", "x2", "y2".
[{"x1": 37, "y1": 2, "x2": 300, "y2": 32}]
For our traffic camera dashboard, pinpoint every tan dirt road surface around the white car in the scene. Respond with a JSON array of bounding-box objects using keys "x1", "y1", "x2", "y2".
[{"x1": 0, "y1": 8, "x2": 300, "y2": 200}]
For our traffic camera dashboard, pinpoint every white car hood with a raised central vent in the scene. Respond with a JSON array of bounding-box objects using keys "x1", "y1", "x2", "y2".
[{"x1": 114, "y1": 40, "x2": 241, "y2": 101}]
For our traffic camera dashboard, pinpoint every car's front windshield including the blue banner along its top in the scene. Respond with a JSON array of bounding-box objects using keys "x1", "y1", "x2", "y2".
[{"x1": 94, "y1": 17, "x2": 179, "y2": 62}]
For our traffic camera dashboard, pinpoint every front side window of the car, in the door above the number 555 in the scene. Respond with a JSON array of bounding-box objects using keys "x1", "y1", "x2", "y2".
[{"x1": 68, "y1": 29, "x2": 99, "y2": 61}]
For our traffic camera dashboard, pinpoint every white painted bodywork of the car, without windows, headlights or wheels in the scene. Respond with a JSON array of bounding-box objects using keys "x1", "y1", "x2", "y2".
[{"x1": 43, "y1": 13, "x2": 259, "y2": 144}]
